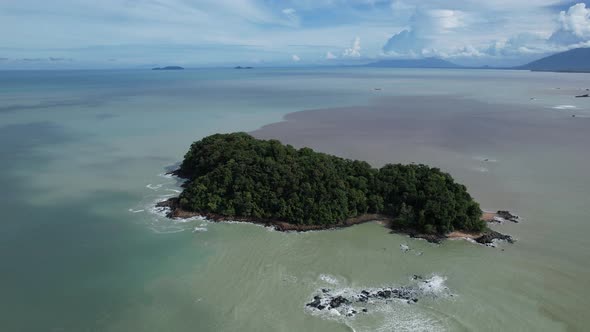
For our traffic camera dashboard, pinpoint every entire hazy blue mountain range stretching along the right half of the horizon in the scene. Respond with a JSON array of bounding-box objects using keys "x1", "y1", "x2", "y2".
[{"x1": 365, "y1": 48, "x2": 590, "y2": 72}]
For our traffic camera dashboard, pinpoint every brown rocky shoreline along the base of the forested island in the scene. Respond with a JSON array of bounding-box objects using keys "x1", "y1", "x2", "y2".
[{"x1": 156, "y1": 195, "x2": 518, "y2": 246}]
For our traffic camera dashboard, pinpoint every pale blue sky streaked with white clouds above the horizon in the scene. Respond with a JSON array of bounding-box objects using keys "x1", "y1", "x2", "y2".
[{"x1": 0, "y1": 0, "x2": 590, "y2": 69}]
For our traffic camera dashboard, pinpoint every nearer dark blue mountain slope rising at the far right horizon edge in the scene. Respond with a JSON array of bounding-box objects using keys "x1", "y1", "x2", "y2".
[{"x1": 513, "y1": 48, "x2": 590, "y2": 72}]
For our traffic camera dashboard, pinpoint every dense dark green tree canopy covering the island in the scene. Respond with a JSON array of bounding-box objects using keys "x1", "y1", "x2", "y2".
[{"x1": 177, "y1": 133, "x2": 485, "y2": 234}]
